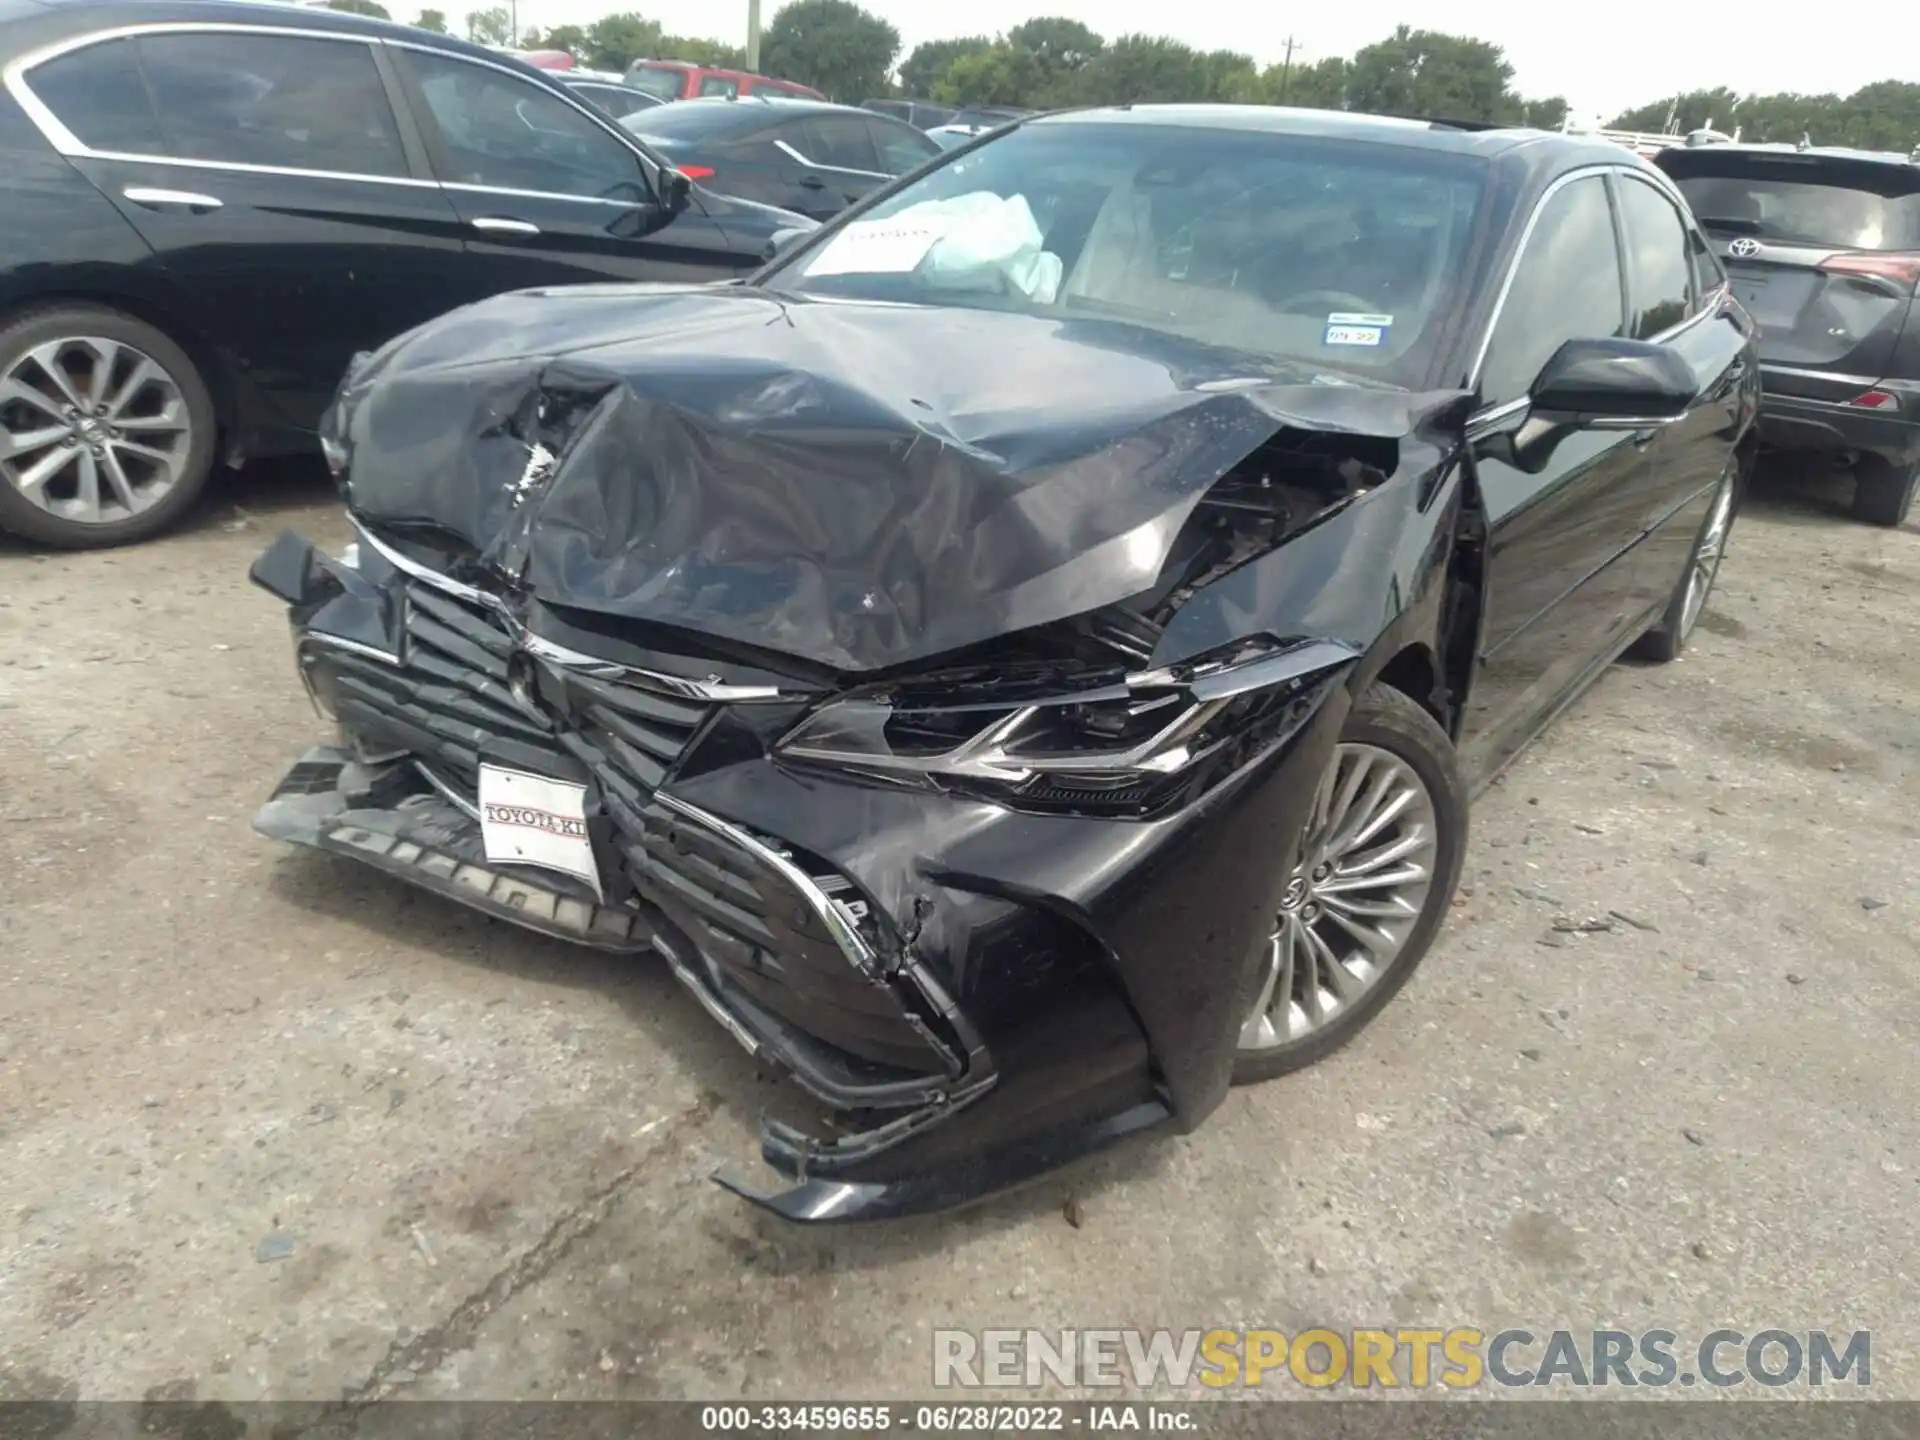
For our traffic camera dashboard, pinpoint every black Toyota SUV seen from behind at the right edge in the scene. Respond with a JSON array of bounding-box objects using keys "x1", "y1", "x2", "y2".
[{"x1": 1655, "y1": 144, "x2": 1920, "y2": 526}]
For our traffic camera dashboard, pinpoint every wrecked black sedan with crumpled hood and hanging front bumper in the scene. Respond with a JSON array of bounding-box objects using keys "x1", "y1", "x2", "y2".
[{"x1": 253, "y1": 106, "x2": 1757, "y2": 1219}]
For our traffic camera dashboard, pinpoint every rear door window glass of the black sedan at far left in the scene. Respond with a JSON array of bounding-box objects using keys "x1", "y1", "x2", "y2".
[{"x1": 134, "y1": 33, "x2": 407, "y2": 175}]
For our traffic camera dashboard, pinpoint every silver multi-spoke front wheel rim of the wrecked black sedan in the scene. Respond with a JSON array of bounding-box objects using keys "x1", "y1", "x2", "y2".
[{"x1": 1240, "y1": 745, "x2": 1436, "y2": 1050}]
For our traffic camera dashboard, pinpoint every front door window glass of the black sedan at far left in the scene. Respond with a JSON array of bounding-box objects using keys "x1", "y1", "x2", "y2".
[{"x1": 409, "y1": 52, "x2": 645, "y2": 204}]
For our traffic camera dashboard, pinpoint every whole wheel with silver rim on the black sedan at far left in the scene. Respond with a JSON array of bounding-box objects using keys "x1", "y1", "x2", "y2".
[{"x1": 0, "y1": 305, "x2": 215, "y2": 549}]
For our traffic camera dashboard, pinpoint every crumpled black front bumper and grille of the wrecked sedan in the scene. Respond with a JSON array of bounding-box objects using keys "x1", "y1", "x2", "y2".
[{"x1": 255, "y1": 536, "x2": 1346, "y2": 1221}]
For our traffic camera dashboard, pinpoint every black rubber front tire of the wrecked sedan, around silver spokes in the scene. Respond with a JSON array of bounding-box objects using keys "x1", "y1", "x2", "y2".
[{"x1": 1233, "y1": 685, "x2": 1467, "y2": 1085}]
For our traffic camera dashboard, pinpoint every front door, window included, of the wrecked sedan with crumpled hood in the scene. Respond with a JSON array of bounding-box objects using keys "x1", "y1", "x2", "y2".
[{"x1": 1463, "y1": 171, "x2": 1647, "y2": 791}]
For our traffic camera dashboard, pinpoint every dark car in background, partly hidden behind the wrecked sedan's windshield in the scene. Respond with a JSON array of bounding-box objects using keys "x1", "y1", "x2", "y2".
[{"x1": 622, "y1": 96, "x2": 941, "y2": 221}]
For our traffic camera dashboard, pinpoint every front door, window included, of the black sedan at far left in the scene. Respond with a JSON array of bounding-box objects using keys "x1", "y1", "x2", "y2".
[{"x1": 392, "y1": 42, "x2": 762, "y2": 294}]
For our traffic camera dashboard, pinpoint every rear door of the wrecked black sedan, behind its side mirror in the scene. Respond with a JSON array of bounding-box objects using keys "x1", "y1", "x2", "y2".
[{"x1": 1615, "y1": 171, "x2": 1747, "y2": 605}]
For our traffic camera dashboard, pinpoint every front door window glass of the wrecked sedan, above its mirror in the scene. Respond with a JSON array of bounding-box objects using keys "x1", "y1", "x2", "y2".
[{"x1": 1480, "y1": 175, "x2": 1626, "y2": 405}]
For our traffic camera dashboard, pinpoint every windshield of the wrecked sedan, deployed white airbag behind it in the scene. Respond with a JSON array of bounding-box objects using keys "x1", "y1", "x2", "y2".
[{"x1": 766, "y1": 121, "x2": 1486, "y2": 386}]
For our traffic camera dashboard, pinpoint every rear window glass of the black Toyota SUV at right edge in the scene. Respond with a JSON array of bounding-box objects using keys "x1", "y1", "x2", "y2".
[{"x1": 1667, "y1": 156, "x2": 1920, "y2": 250}]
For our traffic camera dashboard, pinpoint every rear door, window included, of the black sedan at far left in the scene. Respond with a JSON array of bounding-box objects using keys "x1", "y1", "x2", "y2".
[{"x1": 21, "y1": 25, "x2": 470, "y2": 426}]
